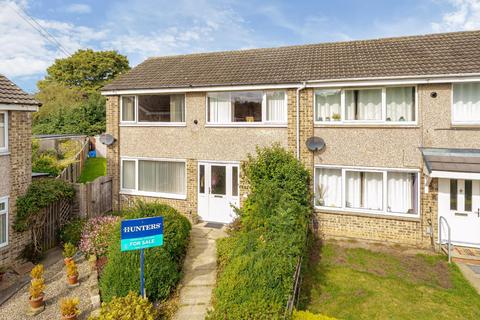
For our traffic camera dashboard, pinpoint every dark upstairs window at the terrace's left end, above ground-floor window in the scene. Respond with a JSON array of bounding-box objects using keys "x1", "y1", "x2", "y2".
[{"x1": 121, "y1": 94, "x2": 185, "y2": 124}]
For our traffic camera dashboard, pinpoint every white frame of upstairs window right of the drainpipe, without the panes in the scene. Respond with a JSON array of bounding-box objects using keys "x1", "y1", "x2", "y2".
[{"x1": 313, "y1": 85, "x2": 418, "y2": 127}]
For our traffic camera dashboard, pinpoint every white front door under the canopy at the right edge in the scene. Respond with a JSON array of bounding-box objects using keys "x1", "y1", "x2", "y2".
[{"x1": 438, "y1": 179, "x2": 480, "y2": 248}]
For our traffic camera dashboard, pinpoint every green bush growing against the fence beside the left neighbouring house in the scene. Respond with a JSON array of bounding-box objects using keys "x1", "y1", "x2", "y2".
[{"x1": 13, "y1": 179, "x2": 75, "y2": 232}]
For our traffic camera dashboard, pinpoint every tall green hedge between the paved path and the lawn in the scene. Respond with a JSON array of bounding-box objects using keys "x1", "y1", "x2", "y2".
[{"x1": 209, "y1": 146, "x2": 312, "y2": 319}]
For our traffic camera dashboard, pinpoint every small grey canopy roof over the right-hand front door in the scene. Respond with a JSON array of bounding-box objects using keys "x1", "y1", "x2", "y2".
[{"x1": 420, "y1": 148, "x2": 480, "y2": 173}]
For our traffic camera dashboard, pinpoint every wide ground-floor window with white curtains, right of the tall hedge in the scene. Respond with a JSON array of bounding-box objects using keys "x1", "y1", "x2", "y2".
[{"x1": 315, "y1": 166, "x2": 419, "y2": 215}]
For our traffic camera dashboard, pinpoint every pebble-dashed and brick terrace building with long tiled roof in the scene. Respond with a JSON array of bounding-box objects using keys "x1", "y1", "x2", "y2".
[{"x1": 102, "y1": 31, "x2": 480, "y2": 247}]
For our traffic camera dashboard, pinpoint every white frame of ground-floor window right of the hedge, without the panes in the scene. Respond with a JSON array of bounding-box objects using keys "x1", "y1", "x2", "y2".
[{"x1": 313, "y1": 165, "x2": 421, "y2": 218}]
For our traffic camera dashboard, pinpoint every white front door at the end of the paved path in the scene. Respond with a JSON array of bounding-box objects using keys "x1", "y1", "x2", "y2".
[{"x1": 198, "y1": 162, "x2": 240, "y2": 223}]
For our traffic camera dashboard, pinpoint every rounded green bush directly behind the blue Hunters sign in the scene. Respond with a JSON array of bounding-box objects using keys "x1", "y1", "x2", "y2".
[{"x1": 100, "y1": 202, "x2": 191, "y2": 302}]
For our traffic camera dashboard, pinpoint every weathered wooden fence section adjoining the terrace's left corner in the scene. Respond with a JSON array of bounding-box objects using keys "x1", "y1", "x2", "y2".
[{"x1": 74, "y1": 177, "x2": 113, "y2": 218}]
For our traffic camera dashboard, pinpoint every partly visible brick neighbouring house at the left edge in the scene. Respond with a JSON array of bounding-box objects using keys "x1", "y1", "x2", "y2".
[{"x1": 0, "y1": 74, "x2": 39, "y2": 266}]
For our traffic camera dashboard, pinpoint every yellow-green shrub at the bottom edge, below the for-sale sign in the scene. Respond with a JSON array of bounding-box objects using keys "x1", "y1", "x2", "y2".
[{"x1": 89, "y1": 292, "x2": 158, "y2": 320}]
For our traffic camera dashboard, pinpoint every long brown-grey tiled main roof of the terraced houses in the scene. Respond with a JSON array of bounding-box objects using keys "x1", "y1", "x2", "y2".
[{"x1": 102, "y1": 31, "x2": 480, "y2": 91}]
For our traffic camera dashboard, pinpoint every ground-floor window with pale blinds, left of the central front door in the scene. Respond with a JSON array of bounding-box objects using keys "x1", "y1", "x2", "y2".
[{"x1": 121, "y1": 158, "x2": 186, "y2": 198}]
